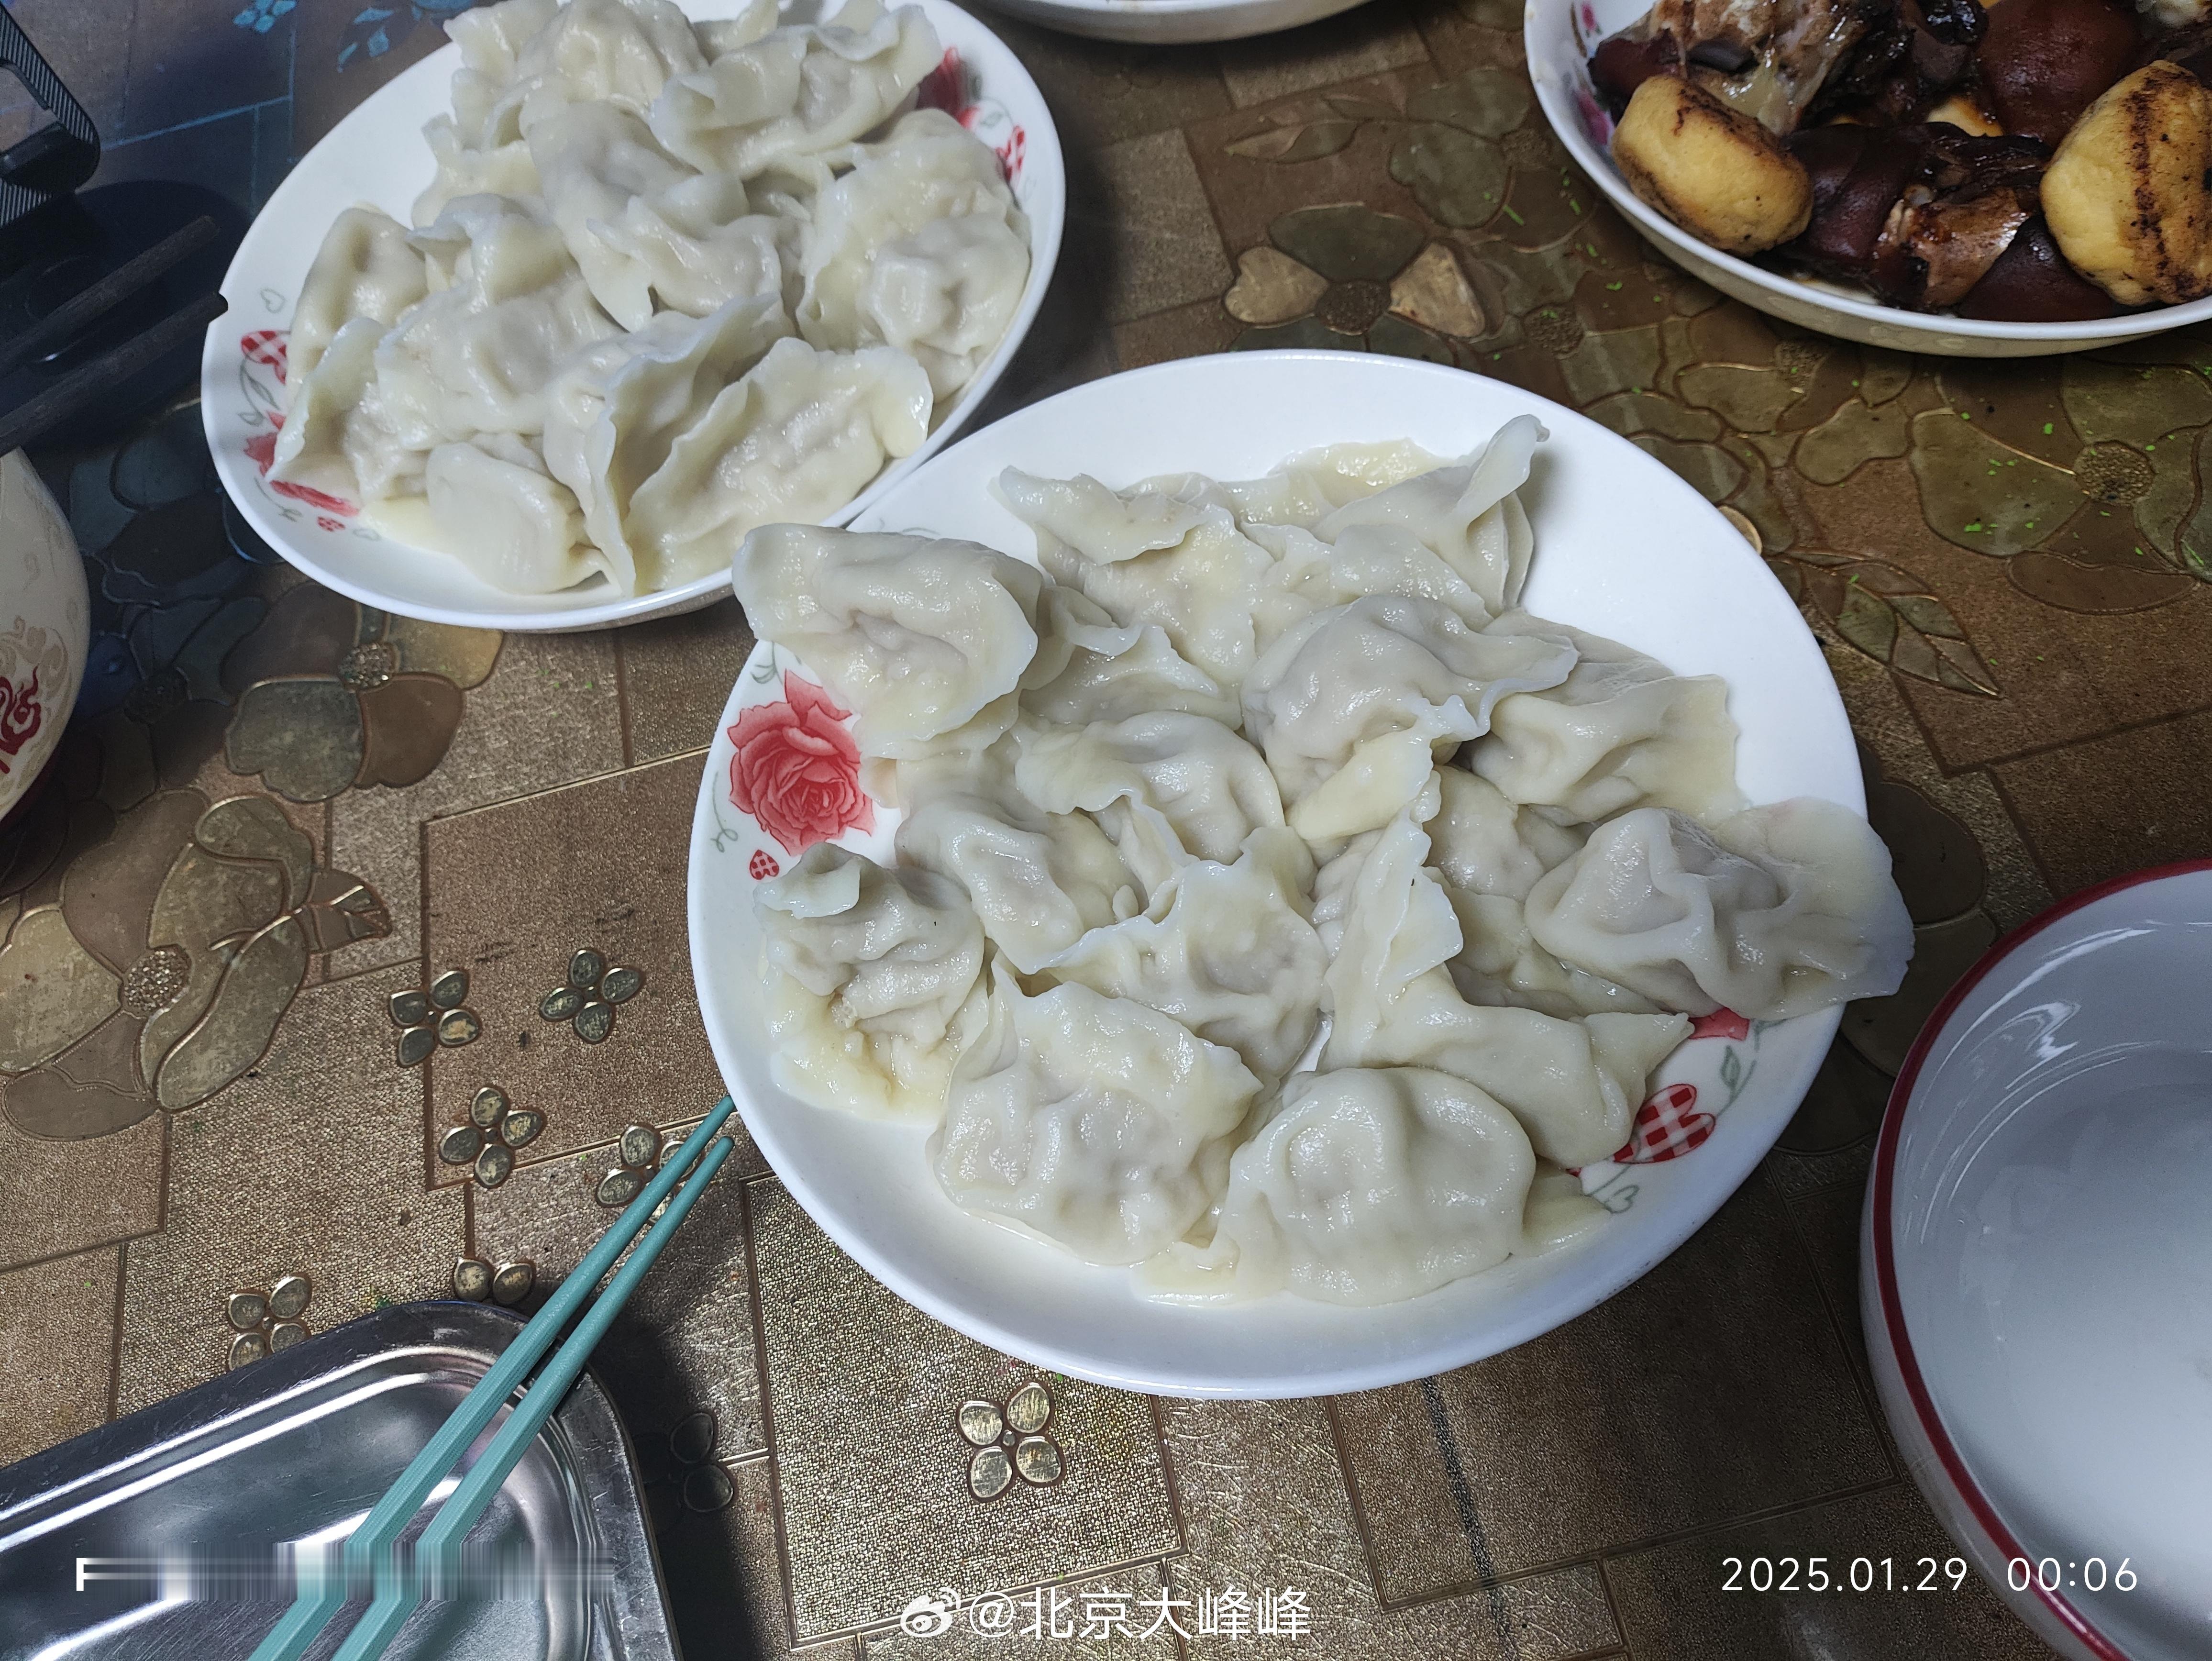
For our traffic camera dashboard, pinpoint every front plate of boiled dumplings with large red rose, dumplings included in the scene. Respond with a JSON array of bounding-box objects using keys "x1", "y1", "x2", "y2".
[{"x1": 690, "y1": 352, "x2": 1911, "y2": 1398}]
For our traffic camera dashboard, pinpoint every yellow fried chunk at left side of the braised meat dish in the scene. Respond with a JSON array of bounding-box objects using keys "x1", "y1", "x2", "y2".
[{"x1": 1613, "y1": 75, "x2": 1812, "y2": 255}]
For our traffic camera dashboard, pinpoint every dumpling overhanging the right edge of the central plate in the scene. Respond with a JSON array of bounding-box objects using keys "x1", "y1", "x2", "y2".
[{"x1": 1528, "y1": 796, "x2": 1913, "y2": 1019}]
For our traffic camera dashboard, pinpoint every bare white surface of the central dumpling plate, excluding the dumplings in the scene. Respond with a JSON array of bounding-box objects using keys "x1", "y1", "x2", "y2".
[{"x1": 690, "y1": 352, "x2": 1865, "y2": 1398}]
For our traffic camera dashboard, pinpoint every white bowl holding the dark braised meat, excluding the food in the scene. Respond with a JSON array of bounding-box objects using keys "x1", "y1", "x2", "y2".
[{"x1": 1522, "y1": 0, "x2": 2212, "y2": 358}]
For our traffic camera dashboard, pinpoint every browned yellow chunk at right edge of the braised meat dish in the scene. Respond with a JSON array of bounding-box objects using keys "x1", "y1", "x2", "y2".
[{"x1": 2044, "y1": 62, "x2": 2212, "y2": 305}]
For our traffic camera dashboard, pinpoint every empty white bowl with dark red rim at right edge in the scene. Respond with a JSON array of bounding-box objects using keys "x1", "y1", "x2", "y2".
[{"x1": 1860, "y1": 860, "x2": 2212, "y2": 1661}]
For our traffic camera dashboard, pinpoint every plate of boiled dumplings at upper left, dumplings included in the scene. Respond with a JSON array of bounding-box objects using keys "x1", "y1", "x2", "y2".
[{"x1": 201, "y1": 0, "x2": 1066, "y2": 631}]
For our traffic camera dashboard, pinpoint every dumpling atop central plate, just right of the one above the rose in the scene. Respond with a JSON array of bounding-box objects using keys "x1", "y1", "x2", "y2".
[{"x1": 997, "y1": 466, "x2": 1272, "y2": 686}]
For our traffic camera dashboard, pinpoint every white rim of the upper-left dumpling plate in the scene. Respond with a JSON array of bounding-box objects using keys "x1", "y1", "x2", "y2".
[{"x1": 199, "y1": 0, "x2": 1068, "y2": 632}]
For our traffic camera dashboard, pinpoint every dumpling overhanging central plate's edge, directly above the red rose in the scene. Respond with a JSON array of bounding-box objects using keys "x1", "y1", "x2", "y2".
[{"x1": 730, "y1": 522, "x2": 1044, "y2": 756}]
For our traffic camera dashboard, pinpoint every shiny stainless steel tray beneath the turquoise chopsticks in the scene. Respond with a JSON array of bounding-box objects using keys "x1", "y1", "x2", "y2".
[{"x1": 0, "y1": 1303, "x2": 677, "y2": 1661}]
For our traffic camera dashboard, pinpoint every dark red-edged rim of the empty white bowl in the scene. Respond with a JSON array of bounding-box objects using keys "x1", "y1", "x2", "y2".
[{"x1": 1865, "y1": 856, "x2": 2212, "y2": 1661}]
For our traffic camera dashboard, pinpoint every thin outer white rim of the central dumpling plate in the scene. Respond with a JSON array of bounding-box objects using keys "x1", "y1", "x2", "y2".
[{"x1": 686, "y1": 349, "x2": 1865, "y2": 1400}]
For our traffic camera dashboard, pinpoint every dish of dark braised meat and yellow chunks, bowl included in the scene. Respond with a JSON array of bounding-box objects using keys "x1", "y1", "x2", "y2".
[{"x1": 1526, "y1": 0, "x2": 2212, "y2": 356}]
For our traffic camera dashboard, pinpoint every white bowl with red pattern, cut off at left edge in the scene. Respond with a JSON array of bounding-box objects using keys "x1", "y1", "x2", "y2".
[{"x1": 0, "y1": 449, "x2": 91, "y2": 820}]
